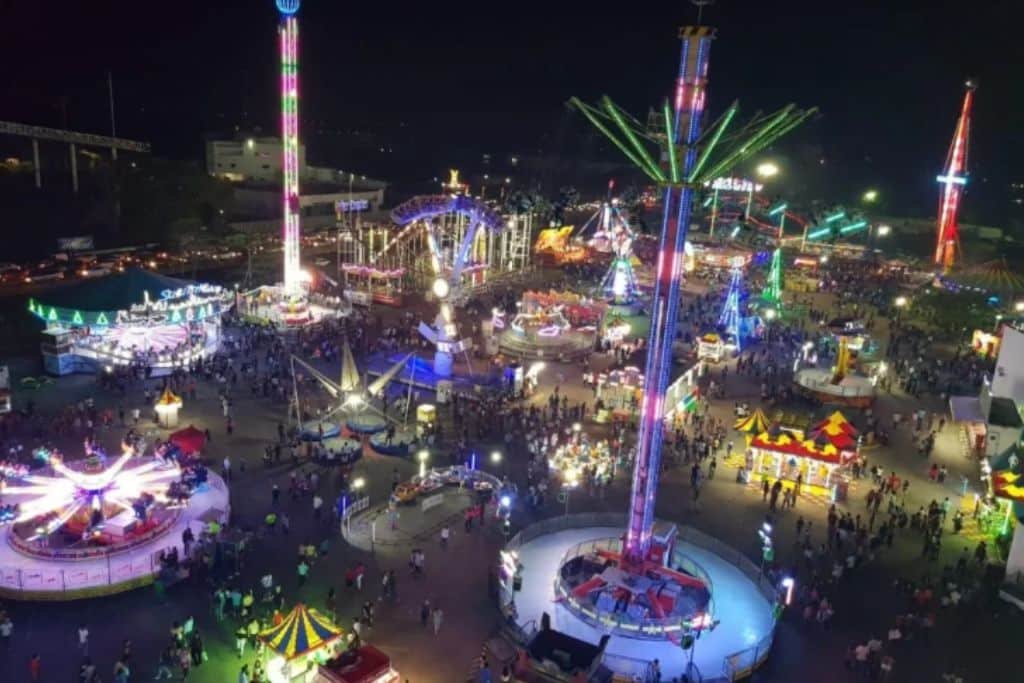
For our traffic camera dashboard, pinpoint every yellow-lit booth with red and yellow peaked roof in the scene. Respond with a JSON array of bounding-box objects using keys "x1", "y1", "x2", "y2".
[{"x1": 746, "y1": 412, "x2": 857, "y2": 502}]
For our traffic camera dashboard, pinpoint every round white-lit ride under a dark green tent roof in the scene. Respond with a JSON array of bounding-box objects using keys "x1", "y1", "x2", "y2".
[{"x1": 29, "y1": 268, "x2": 232, "y2": 376}]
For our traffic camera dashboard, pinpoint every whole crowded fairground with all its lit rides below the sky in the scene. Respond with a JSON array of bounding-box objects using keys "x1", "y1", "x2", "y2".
[{"x1": 0, "y1": 0, "x2": 1024, "y2": 683}]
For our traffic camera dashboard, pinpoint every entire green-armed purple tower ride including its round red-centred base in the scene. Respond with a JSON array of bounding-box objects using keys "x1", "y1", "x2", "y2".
[{"x1": 495, "y1": 20, "x2": 813, "y2": 676}]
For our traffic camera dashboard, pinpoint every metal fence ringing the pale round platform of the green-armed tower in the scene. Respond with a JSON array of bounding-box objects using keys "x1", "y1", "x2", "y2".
[{"x1": 505, "y1": 512, "x2": 778, "y2": 681}]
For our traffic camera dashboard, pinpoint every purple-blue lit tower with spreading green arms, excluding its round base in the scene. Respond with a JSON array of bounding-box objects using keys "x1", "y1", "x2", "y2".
[{"x1": 569, "y1": 26, "x2": 816, "y2": 567}]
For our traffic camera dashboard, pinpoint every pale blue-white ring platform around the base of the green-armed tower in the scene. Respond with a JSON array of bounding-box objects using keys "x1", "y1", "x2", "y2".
[{"x1": 503, "y1": 514, "x2": 775, "y2": 680}]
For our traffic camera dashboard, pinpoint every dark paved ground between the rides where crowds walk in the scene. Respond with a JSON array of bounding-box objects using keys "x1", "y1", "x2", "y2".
[{"x1": 0, "y1": 278, "x2": 1024, "y2": 683}]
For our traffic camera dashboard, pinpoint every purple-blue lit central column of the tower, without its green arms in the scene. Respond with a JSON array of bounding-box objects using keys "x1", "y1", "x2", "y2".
[{"x1": 623, "y1": 27, "x2": 714, "y2": 565}]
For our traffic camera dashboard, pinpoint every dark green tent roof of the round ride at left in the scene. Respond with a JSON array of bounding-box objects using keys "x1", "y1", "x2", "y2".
[{"x1": 38, "y1": 268, "x2": 195, "y2": 311}]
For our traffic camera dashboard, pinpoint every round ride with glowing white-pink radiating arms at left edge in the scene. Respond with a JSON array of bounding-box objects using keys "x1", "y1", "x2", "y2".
[{"x1": 0, "y1": 440, "x2": 229, "y2": 599}]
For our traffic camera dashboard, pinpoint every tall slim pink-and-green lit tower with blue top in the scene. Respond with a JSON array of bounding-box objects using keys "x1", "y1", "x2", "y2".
[{"x1": 275, "y1": 0, "x2": 302, "y2": 296}]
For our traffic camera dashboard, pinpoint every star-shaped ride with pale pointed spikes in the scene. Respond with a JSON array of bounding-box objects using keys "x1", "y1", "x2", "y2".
[{"x1": 292, "y1": 342, "x2": 413, "y2": 440}]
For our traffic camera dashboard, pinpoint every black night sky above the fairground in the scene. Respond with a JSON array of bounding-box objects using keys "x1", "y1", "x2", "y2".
[{"x1": 0, "y1": 0, "x2": 1024, "y2": 220}]
